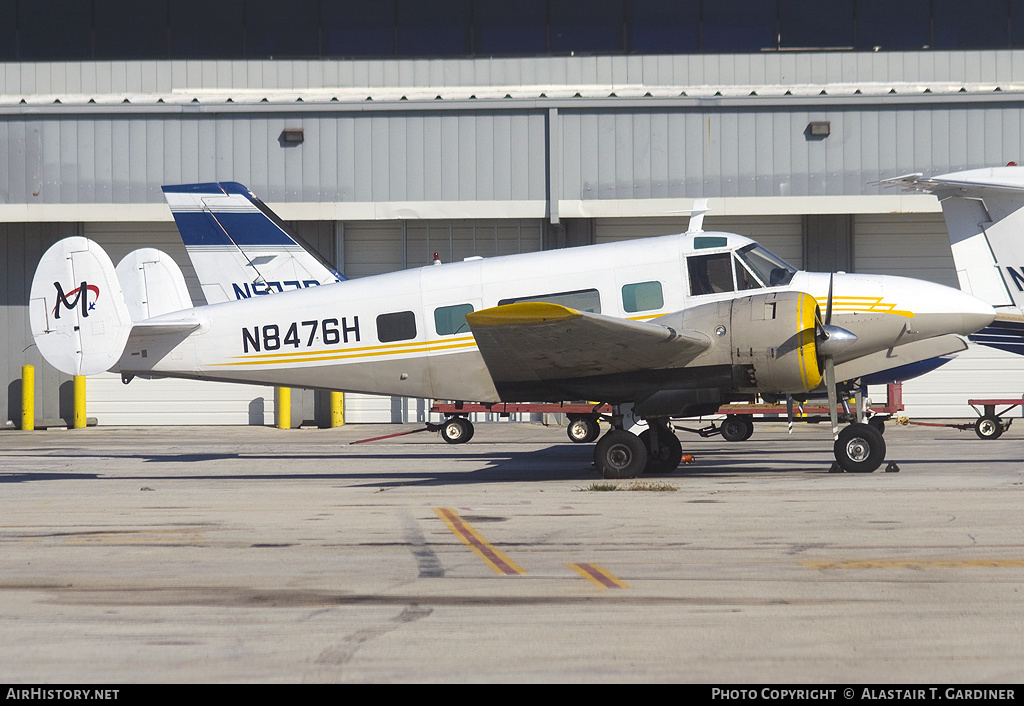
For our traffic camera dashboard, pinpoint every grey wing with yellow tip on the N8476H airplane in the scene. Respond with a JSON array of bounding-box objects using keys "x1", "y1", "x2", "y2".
[{"x1": 466, "y1": 302, "x2": 711, "y2": 385}]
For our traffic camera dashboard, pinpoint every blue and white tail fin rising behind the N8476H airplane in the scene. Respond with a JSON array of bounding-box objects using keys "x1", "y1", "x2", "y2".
[{"x1": 163, "y1": 181, "x2": 345, "y2": 304}]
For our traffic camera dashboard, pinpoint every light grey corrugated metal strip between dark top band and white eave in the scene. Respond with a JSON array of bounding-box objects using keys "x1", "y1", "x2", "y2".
[{"x1": 6, "y1": 50, "x2": 1024, "y2": 96}]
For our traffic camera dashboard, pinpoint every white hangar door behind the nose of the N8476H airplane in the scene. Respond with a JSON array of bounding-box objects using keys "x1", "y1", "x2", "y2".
[{"x1": 853, "y1": 213, "x2": 1024, "y2": 419}]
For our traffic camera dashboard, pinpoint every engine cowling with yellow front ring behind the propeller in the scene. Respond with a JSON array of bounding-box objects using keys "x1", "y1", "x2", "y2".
[{"x1": 730, "y1": 292, "x2": 821, "y2": 393}]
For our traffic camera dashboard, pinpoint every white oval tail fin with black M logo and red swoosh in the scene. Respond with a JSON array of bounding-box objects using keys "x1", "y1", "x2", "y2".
[{"x1": 29, "y1": 237, "x2": 132, "y2": 375}]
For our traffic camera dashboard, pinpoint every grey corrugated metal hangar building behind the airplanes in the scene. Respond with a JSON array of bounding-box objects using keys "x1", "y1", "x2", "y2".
[{"x1": 0, "y1": 0, "x2": 1024, "y2": 425}]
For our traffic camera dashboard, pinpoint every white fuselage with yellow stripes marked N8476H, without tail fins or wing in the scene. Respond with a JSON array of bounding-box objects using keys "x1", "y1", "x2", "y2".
[{"x1": 115, "y1": 233, "x2": 991, "y2": 403}]
